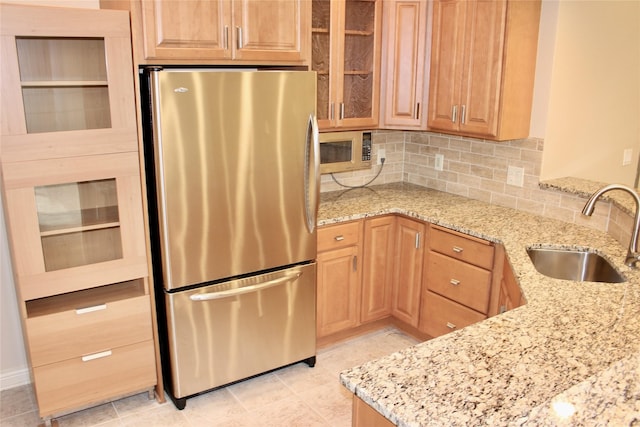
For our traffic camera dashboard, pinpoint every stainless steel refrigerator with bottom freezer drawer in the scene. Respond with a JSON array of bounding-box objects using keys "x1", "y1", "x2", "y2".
[{"x1": 140, "y1": 67, "x2": 319, "y2": 409}]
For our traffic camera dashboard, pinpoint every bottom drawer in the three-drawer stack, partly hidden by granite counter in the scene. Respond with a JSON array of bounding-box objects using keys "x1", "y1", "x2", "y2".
[{"x1": 420, "y1": 291, "x2": 487, "y2": 337}]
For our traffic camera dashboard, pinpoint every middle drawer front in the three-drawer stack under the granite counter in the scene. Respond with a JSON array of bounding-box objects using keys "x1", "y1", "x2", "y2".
[{"x1": 427, "y1": 252, "x2": 491, "y2": 314}]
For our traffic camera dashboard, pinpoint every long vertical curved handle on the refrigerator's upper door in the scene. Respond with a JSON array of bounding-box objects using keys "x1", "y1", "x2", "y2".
[{"x1": 304, "y1": 114, "x2": 320, "y2": 233}]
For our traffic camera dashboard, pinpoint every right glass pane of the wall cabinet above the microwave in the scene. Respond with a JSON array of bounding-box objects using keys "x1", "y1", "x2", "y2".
[{"x1": 343, "y1": 0, "x2": 376, "y2": 119}]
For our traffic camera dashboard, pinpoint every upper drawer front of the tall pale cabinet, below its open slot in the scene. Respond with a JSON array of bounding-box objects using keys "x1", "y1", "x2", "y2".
[{"x1": 26, "y1": 295, "x2": 152, "y2": 366}]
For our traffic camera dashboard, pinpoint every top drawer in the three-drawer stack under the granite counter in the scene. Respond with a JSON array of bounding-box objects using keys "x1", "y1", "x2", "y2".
[{"x1": 429, "y1": 227, "x2": 494, "y2": 270}]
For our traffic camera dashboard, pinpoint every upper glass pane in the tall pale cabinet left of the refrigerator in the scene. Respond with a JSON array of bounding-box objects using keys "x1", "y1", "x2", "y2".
[{"x1": 16, "y1": 37, "x2": 111, "y2": 133}]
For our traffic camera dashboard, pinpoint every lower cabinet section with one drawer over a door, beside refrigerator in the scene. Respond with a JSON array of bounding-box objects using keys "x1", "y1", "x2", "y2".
[{"x1": 316, "y1": 221, "x2": 362, "y2": 338}]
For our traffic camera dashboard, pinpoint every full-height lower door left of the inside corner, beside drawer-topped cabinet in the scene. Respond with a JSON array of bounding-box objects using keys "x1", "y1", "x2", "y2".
[{"x1": 360, "y1": 216, "x2": 395, "y2": 322}]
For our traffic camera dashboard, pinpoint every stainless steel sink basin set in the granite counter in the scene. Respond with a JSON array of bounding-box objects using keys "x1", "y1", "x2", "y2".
[{"x1": 527, "y1": 248, "x2": 625, "y2": 283}]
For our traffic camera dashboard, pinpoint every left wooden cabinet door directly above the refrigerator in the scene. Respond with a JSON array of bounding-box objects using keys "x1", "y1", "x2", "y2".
[{"x1": 141, "y1": 0, "x2": 231, "y2": 59}]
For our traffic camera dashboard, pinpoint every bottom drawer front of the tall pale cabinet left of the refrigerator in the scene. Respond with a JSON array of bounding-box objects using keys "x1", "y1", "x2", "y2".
[{"x1": 33, "y1": 341, "x2": 156, "y2": 417}]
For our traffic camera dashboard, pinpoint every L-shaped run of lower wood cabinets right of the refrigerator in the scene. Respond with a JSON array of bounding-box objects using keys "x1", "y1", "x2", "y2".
[{"x1": 317, "y1": 219, "x2": 523, "y2": 342}]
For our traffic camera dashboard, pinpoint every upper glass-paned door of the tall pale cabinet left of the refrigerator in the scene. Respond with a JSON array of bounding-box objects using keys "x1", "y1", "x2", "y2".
[{"x1": 0, "y1": 4, "x2": 138, "y2": 162}]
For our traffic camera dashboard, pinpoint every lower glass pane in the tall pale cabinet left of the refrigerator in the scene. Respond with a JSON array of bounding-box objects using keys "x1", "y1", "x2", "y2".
[{"x1": 35, "y1": 178, "x2": 122, "y2": 271}]
